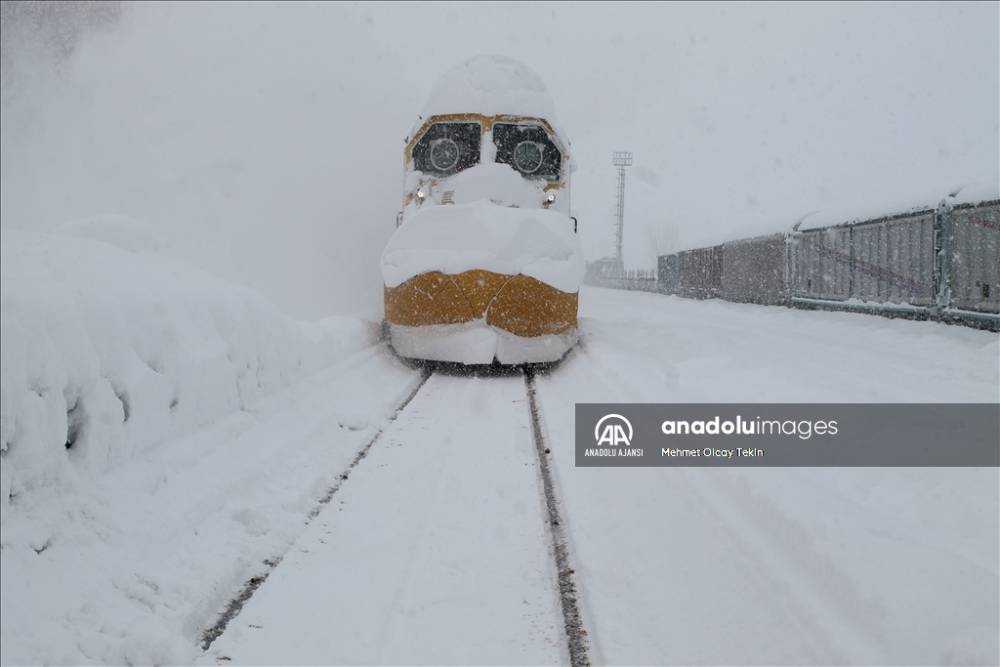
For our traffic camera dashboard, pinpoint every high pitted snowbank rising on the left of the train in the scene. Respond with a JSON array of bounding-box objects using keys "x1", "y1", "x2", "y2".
[{"x1": 0, "y1": 230, "x2": 374, "y2": 517}]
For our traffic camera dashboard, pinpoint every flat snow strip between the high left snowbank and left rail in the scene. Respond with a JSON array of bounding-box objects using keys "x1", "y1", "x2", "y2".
[{"x1": 0, "y1": 347, "x2": 414, "y2": 665}]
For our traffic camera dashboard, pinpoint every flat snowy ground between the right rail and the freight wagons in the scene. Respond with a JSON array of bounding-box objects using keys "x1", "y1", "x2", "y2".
[{"x1": 539, "y1": 290, "x2": 1000, "y2": 665}]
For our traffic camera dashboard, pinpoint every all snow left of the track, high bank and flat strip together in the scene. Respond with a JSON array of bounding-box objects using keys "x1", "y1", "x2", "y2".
[{"x1": 0, "y1": 226, "x2": 415, "y2": 664}]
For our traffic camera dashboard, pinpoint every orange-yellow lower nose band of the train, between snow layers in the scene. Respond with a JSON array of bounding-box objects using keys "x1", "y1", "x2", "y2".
[{"x1": 385, "y1": 269, "x2": 578, "y2": 337}]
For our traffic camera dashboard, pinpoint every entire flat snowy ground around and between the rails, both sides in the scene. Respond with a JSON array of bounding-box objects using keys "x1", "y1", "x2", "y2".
[{"x1": 0, "y1": 282, "x2": 1000, "y2": 664}]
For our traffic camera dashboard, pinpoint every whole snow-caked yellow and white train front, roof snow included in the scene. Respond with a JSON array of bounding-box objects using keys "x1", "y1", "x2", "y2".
[{"x1": 382, "y1": 56, "x2": 584, "y2": 365}]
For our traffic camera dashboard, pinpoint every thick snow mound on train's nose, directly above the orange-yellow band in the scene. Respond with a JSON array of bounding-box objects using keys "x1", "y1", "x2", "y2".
[{"x1": 382, "y1": 200, "x2": 585, "y2": 292}]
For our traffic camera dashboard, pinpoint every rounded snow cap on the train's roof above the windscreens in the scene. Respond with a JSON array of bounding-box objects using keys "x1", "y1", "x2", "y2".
[{"x1": 421, "y1": 55, "x2": 555, "y2": 124}]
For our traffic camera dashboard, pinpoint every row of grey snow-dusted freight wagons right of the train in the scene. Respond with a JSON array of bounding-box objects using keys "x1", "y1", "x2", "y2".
[{"x1": 648, "y1": 200, "x2": 1000, "y2": 330}]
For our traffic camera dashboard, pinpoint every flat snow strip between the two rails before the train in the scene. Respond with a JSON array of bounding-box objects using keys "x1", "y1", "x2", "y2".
[{"x1": 204, "y1": 375, "x2": 565, "y2": 665}]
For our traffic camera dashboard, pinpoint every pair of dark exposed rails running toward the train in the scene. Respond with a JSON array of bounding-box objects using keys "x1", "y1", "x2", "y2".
[{"x1": 201, "y1": 364, "x2": 591, "y2": 667}]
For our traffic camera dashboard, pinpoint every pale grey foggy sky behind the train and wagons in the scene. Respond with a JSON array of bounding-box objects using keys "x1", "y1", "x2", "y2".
[{"x1": 0, "y1": 2, "x2": 1000, "y2": 315}]
